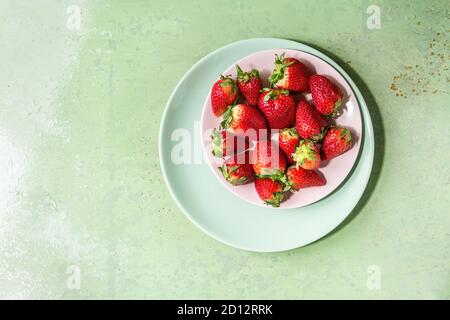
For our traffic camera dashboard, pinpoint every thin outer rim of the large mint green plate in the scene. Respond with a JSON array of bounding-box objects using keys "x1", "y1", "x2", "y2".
[{"x1": 158, "y1": 37, "x2": 375, "y2": 252}]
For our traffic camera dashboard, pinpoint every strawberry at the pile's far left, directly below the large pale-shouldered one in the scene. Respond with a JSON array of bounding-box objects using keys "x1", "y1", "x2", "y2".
[{"x1": 211, "y1": 129, "x2": 249, "y2": 158}]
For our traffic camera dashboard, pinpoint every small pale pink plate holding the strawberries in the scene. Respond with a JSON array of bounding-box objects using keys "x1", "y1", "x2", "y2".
[{"x1": 201, "y1": 49, "x2": 362, "y2": 209}]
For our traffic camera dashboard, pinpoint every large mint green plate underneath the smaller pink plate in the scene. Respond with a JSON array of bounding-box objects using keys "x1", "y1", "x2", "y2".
[{"x1": 159, "y1": 38, "x2": 374, "y2": 252}]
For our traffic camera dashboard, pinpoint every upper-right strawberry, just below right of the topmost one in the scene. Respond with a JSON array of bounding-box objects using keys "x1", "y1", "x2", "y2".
[{"x1": 309, "y1": 74, "x2": 342, "y2": 118}]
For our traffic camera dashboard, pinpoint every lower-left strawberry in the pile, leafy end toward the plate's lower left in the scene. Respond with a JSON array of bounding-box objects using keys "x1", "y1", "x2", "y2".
[{"x1": 219, "y1": 152, "x2": 254, "y2": 186}]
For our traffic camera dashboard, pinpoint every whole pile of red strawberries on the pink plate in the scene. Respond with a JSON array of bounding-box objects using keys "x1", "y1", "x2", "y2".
[{"x1": 211, "y1": 53, "x2": 352, "y2": 207}]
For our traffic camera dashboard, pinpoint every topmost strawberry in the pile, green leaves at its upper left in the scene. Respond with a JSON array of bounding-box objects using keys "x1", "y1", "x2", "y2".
[{"x1": 269, "y1": 53, "x2": 309, "y2": 91}]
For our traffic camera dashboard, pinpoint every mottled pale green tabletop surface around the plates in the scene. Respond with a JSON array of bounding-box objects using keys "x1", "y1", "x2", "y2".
[{"x1": 0, "y1": 0, "x2": 450, "y2": 299}]
